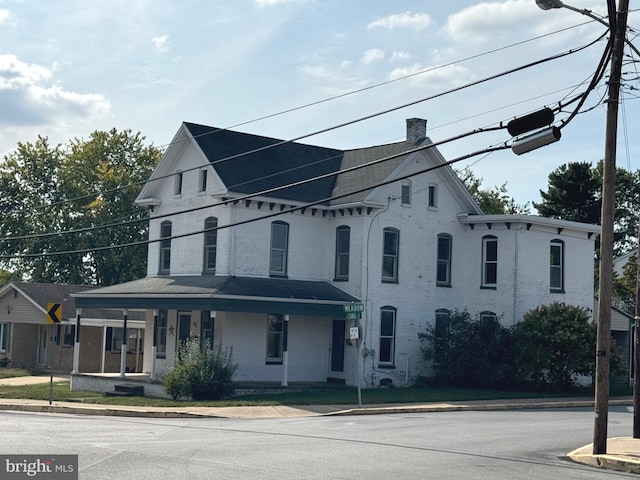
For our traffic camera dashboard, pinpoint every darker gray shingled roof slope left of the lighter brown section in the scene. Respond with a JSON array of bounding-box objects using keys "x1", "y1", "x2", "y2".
[{"x1": 184, "y1": 122, "x2": 343, "y2": 202}]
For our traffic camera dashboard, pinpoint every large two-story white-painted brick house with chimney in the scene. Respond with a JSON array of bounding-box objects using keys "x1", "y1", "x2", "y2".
[{"x1": 74, "y1": 119, "x2": 599, "y2": 392}]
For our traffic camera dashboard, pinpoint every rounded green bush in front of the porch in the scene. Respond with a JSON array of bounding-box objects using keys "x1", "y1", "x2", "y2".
[{"x1": 162, "y1": 338, "x2": 238, "y2": 400}]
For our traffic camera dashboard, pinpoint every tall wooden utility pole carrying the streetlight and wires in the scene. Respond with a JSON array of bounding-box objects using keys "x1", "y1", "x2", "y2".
[{"x1": 593, "y1": 0, "x2": 629, "y2": 455}]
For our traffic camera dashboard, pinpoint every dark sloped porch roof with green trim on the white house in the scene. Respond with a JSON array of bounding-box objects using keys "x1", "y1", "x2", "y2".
[{"x1": 72, "y1": 275, "x2": 359, "y2": 318}]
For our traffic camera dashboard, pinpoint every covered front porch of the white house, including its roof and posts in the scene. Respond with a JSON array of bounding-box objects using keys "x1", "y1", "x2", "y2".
[{"x1": 72, "y1": 276, "x2": 358, "y2": 396}]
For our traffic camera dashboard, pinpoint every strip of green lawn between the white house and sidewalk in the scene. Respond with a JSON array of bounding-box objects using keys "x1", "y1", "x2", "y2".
[{"x1": 0, "y1": 369, "x2": 631, "y2": 407}]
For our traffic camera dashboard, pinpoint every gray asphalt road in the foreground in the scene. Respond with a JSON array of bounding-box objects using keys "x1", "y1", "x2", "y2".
[{"x1": 0, "y1": 407, "x2": 637, "y2": 480}]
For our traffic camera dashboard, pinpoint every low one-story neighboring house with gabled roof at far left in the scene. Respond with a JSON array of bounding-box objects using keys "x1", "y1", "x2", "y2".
[{"x1": 0, "y1": 282, "x2": 144, "y2": 372}]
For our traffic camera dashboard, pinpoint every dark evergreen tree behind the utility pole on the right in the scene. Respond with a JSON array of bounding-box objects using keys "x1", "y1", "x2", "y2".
[{"x1": 533, "y1": 162, "x2": 640, "y2": 254}]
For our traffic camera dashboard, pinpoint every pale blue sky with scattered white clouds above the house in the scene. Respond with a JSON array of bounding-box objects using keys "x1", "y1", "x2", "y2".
[{"x1": 0, "y1": 0, "x2": 640, "y2": 203}]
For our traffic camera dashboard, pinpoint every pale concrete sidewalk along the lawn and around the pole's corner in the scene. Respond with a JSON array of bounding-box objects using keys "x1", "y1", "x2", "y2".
[{"x1": 0, "y1": 376, "x2": 640, "y2": 474}]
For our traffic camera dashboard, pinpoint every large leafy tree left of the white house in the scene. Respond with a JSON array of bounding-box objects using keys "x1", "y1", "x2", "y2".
[{"x1": 0, "y1": 129, "x2": 161, "y2": 286}]
